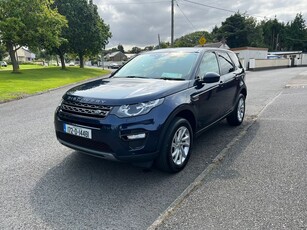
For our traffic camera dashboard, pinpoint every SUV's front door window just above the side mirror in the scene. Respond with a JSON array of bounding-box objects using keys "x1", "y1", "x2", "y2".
[{"x1": 198, "y1": 52, "x2": 220, "y2": 77}]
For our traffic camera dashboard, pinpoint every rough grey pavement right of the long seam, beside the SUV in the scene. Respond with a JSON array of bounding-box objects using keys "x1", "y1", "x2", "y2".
[{"x1": 149, "y1": 80, "x2": 307, "y2": 230}]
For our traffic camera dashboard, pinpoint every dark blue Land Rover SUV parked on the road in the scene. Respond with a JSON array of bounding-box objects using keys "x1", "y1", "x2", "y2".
[{"x1": 55, "y1": 47, "x2": 247, "y2": 172}]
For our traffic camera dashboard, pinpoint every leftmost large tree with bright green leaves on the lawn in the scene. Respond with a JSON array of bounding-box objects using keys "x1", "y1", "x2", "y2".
[{"x1": 0, "y1": 0, "x2": 67, "y2": 73}]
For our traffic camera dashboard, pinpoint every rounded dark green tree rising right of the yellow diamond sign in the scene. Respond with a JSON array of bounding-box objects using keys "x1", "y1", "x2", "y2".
[{"x1": 212, "y1": 13, "x2": 263, "y2": 48}]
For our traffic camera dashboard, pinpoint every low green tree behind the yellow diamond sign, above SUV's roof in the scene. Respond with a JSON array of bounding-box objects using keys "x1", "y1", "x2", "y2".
[{"x1": 174, "y1": 31, "x2": 213, "y2": 47}]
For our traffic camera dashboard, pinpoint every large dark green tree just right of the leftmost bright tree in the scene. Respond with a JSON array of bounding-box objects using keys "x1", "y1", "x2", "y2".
[{"x1": 54, "y1": 0, "x2": 111, "y2": 68}]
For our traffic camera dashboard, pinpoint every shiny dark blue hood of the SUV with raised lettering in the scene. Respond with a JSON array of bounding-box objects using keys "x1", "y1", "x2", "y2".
[{"x1": 64, "y1": 78, "x2": 189, "y2": 105}]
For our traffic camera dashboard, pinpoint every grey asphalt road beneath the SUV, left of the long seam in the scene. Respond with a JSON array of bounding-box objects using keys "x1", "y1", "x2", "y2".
[{"x1": 0, "y1": 68, "x2": 307, "y2": 229}]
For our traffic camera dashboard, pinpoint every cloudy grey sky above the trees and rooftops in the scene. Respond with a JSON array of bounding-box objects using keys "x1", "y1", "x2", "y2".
[{"x1": 93, "y1": 0, "x2": 307, "y2": 51}]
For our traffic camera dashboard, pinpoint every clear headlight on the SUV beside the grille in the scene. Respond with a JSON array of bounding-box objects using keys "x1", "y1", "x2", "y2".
[{"x1": 114, "y1": 98, "x2": 164, "y2": 117}]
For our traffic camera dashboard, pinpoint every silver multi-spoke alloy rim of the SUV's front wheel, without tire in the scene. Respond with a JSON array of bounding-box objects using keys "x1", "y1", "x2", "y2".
[{"x1": 171, "y1": 126, "x2": 191, "y2": 166}]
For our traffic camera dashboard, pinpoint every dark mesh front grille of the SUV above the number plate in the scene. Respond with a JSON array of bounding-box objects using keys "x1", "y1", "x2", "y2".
[{"x1": 61, "y1": 101, "x2": 112, "y2": 118}]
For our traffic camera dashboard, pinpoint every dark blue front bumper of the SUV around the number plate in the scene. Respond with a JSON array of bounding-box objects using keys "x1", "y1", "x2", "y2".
[{"x1": 54, "y1": 109, "x2": 163, "y2": 162}]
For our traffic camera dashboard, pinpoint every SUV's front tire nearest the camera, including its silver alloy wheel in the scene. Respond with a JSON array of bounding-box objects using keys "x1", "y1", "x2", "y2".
[{"x1": 155, "y1": 118, "x2": 193, "y2": 173}]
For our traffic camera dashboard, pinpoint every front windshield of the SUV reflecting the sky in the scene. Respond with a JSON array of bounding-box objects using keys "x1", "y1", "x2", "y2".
[{"x1": 114, "y1": 51, "x2": 198, "y2": 80}]
